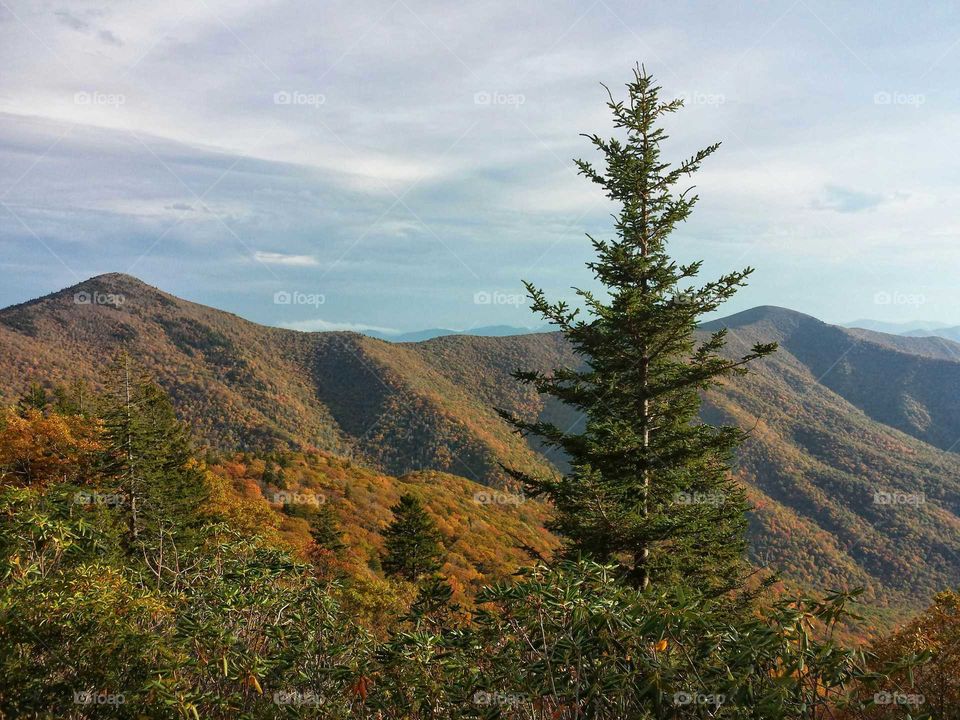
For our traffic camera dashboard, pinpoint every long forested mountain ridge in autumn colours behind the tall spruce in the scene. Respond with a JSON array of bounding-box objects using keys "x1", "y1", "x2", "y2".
[{"x1": 0, "y1": 274, "x2": 960, "y2": 615}]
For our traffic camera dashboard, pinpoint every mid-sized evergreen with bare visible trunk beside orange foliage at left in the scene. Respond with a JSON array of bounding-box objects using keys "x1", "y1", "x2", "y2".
[{"x1": 100, "y1": 353, "x2": 206, "y2": 548}]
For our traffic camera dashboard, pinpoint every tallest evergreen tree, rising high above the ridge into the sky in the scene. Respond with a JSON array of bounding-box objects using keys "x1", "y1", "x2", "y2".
[{"x1": 501, "y1": 68, "x2": 776, "y2": 594}]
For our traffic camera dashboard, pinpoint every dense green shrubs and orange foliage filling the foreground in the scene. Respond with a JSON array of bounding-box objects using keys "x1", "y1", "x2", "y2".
[{"x1": 0, "y1": 382, "x2": 960, "y2": 718}]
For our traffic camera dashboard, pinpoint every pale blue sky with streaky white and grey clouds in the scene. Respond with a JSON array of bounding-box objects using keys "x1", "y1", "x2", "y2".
[{"x1": 0, "y1": 0, "x2": 960, "y2": 332}]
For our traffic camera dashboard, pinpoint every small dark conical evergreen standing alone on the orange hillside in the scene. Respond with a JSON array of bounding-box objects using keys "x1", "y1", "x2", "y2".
[{"x1": 383, "y1": 494, "x2": 443, "y2": 581}]
